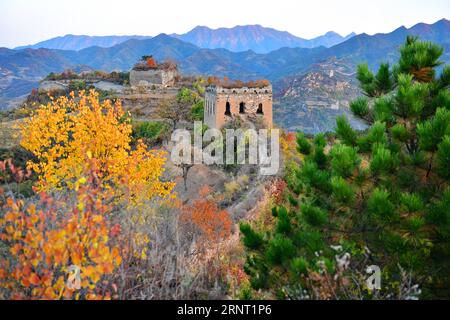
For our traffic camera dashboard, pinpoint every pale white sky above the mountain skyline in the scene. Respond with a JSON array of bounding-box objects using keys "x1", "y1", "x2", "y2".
[{"x1": 0, "y1": 0, "x2": 450, "y2": 48}]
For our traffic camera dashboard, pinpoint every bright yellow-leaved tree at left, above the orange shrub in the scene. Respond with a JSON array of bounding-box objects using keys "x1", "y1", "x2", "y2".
[{"x1": 21, "y1": 90, "x2": 174, "y2": 203}]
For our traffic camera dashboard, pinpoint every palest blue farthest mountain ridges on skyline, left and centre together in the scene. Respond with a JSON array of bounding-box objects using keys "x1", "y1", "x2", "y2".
[{"x1": 15, "y1": 25, "x2": 355, "y2": 53}]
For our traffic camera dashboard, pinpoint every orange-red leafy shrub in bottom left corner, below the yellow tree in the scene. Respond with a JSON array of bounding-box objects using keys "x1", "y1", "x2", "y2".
[{"x1": 0, "y1": 168, "x2": 122, "y2": 299}]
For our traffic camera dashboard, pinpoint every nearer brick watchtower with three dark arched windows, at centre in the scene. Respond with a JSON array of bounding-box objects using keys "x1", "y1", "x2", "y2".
[{"x1": 204, "y1": 80, "x2": 272, "y2": 129}]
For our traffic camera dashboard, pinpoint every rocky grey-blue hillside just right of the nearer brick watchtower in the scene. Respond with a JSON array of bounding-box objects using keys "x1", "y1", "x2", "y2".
[{"x1": 274, "y1": 58, "x2": 364, "y2": 134}]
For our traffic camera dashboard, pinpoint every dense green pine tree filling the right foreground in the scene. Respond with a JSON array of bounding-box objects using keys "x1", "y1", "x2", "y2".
[{"x1": 242, "y1": 37, "x2": 450, "y2": 298}]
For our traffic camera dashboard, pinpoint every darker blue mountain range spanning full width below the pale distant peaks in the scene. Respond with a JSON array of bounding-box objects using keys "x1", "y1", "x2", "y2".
[{"x1": 0, "y1": 19, "x2": 450, "y2": 130}]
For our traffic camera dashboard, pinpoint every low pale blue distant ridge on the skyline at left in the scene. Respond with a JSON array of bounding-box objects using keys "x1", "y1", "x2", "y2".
[{"x1": 15, "y1": 34, "x2": 152, "y2": 51}]
